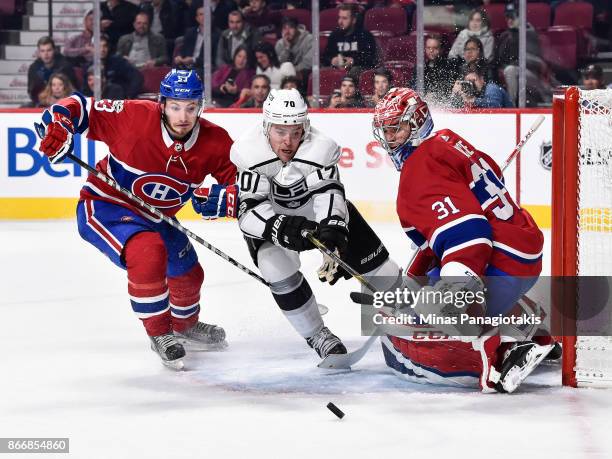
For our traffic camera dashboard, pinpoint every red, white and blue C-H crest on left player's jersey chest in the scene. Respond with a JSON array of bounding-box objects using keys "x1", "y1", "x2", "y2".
[{"x1": 132, "y1": 174, "x2": 189, "y2": 209}]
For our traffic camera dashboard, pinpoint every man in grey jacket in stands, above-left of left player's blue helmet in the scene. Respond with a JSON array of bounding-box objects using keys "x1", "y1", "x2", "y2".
[{"x1": 117, "y1": 12, "x2": 168, "y2": 69}]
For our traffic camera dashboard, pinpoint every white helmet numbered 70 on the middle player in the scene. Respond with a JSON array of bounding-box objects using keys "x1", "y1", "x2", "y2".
[{"x1": 263, "y1": 89, "x2": 310, "y2": 138}]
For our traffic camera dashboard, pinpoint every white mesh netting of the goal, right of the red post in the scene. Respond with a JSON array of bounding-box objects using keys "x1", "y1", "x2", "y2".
[{"x1": 576, "y1": 90, "x2": 612, "y2": 385}]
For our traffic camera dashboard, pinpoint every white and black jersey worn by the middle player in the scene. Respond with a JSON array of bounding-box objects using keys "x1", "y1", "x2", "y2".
[{"x1": 230, "y1": 124, "x2": 348, "y2": 239}]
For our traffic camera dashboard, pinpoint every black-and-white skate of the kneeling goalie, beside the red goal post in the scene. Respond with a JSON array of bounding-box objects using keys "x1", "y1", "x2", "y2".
[{"x1": 495, "y1": 341, "x2": 554, "y2": 393}]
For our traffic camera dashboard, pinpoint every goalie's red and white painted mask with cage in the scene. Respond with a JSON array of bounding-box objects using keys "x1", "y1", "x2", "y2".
[{"x1": 372, "y1": 88, "x2": 433, "y2": 171}]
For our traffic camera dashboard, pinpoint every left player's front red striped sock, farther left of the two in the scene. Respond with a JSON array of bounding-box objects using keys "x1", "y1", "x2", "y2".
[{"x1": 124, "y1": 231, "x2": 172, "y2": 336}]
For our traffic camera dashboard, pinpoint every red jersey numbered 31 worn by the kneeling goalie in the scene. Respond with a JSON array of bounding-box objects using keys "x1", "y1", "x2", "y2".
[{"x1": 397, "y1": 129, "x2": 544, "y2": 276}]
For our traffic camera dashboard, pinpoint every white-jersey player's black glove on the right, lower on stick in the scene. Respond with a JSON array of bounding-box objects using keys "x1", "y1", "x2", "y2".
[{"x1": 317, "y1": 217, "x2": 351, "y2": 285}]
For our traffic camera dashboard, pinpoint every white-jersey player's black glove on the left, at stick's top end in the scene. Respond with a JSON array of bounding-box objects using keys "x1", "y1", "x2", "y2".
[{"x1": 263, "y1": 214, "x2": 317, "y2": 252}]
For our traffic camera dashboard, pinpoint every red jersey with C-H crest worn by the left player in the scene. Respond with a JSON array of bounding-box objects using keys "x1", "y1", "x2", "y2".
[{"x1": 60, "y1": 93, "x2": 236, "y2": 218}]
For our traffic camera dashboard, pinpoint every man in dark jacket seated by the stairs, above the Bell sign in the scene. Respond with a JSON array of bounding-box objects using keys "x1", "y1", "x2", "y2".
[{"x1": 28, "y1": 37, "x2": 77, "y2": 105}]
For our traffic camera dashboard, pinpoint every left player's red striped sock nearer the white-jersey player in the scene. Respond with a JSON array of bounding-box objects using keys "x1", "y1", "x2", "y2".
[{"x1": 168, "y1": 263, "x2": 204, "y2": 332}]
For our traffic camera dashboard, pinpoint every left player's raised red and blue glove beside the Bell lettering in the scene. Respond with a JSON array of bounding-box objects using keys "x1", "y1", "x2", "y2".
[{"x1": 34, "y1": 105, "x2": 74, "y2": 164}]
